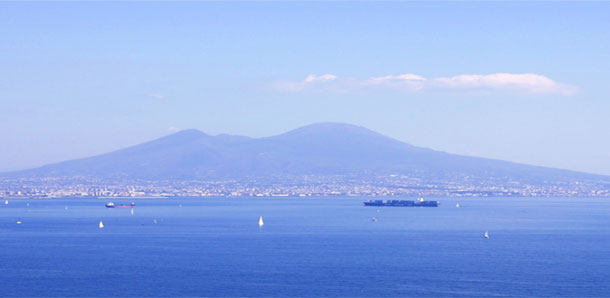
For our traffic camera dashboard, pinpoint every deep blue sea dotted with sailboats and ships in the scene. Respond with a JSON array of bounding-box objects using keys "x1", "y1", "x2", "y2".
[{"x1": 0, "y1": 197, "x2": 610, "y2": 297}]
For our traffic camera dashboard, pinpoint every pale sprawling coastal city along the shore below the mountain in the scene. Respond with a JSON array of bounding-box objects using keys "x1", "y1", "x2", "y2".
[{"x1": 0, "y1": 176, "x2": 610, "y2": 198}]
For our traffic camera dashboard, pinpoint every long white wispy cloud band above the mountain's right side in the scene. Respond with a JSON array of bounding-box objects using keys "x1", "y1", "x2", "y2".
[{"x1": 274, "y1": 73, "x2": 577, "y2": 95}]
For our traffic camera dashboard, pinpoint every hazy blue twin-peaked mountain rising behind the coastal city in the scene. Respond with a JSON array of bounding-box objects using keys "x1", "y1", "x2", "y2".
[{"x1": 2, "y1": 123, "x2": 610, "y2": 184}]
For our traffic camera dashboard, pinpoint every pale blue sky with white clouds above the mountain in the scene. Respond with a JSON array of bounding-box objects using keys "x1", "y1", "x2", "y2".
[{"x1": 0, "y1": 2, "x2": 610, "y2": 175}]
